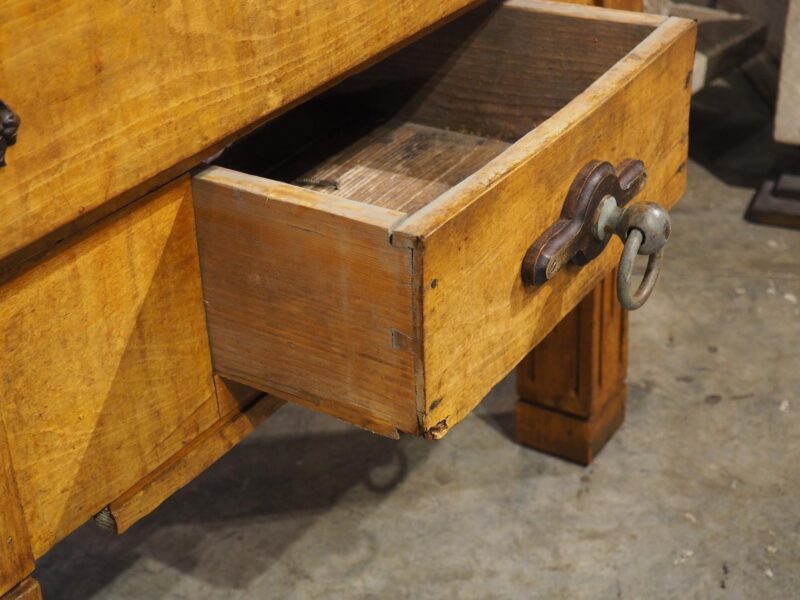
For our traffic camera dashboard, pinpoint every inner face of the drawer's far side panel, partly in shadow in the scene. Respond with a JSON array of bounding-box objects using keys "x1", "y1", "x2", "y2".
[{"x1": 332, "y1": 0, "x2": 663, "y2": 142}]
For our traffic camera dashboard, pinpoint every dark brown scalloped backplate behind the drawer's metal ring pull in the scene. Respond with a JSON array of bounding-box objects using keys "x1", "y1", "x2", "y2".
[{"x1": 522, "y1": 159, "x2": 647, "y2": 285}]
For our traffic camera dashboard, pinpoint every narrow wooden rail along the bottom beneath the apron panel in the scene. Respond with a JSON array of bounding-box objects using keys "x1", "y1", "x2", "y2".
[{"x1": 109, "y1": 395, "x2": 283, "y2": 533}]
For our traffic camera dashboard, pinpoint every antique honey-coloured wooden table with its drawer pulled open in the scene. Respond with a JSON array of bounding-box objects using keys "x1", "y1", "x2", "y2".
[{"x1": 0, "y1": 0, "x2": 694, "y2": 598}]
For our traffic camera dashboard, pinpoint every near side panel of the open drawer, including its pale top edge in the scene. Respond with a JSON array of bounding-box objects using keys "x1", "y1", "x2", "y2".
[{"x1": 193, "y1": 167, "x2": 417, "y2": 436}]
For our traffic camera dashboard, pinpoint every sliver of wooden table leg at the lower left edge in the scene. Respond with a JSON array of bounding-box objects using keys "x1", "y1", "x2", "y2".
[{"x1": 0, "y1": 414, "x2": 33, "y2": 594}]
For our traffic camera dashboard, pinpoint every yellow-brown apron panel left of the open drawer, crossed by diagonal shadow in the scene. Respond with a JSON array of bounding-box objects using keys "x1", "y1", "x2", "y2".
[{"x1": 0, "y1": 178, "x2": 219, "y2": 557}]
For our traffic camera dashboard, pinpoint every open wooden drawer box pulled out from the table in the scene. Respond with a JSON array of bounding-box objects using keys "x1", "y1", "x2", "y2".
[{"x1": 193, "y1": 0, "x2": 695, "y2": 437}]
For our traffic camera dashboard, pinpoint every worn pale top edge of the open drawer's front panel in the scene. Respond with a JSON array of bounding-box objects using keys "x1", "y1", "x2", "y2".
[{"x1": 391, "y1": 14, "x2": 697, "y2": 239}]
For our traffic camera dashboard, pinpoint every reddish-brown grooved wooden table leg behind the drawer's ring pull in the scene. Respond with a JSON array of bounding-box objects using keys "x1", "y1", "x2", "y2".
[{"x1": 517, "y1": 271, "x2": 628, "y2": 465}]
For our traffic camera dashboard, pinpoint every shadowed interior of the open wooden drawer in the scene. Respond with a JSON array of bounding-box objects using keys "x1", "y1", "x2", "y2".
[{"x1": 216, "y1": 1, "x2": 653, "y2": 214}]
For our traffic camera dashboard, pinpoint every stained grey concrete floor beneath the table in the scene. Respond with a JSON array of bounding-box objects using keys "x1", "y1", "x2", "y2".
[{"x1": 37, "y1": 75, "x2": 800, "y2": 600}]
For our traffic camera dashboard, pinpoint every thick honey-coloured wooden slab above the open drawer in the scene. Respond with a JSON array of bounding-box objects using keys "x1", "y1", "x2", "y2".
[{"x1": 0, "y1": 0, "x2": 482, "y2": 270}]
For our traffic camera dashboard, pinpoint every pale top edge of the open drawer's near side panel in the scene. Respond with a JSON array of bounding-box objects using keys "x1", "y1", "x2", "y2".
[{"x1": 192, "y1": 167, "x2": 406, "y2": 231}]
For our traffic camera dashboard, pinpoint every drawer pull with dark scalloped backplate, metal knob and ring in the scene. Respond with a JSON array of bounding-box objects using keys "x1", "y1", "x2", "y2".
[{"x1": 522, "y1": 159, "x2": 671, "y2": 310}]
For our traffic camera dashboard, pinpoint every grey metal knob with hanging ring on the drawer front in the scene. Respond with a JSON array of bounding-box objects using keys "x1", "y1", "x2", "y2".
[{"x1": 592, "y1": 196, "x2": 671, "y2": 310}]
